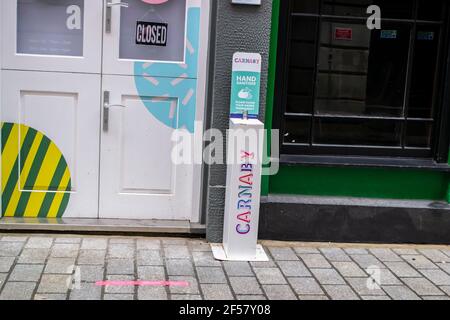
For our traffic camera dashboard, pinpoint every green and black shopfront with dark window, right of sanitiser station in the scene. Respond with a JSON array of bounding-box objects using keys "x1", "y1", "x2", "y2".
[{"x1": 261, "y1": 1, "x2": 450, "y2": 243}]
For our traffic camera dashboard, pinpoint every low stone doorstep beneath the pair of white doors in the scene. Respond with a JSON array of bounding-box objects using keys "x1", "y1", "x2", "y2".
[{"x1": 0, "y1": 218, "x2": 206, "y2": 235}]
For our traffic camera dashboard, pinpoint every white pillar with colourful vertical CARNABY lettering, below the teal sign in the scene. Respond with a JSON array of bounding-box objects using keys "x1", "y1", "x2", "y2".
[{"x1": 223, "y1": 119, "x2": 264, "y2": 261}]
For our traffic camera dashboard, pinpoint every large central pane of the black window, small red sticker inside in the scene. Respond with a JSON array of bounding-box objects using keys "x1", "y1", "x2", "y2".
[{"x1": 315, "y1": 22, "x2": 410, "y2": 116}]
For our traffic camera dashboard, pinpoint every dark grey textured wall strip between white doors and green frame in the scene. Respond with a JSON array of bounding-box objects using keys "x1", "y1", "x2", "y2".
[{"x1": 204, "y1": 0, "x2": 272, "y2": 242}]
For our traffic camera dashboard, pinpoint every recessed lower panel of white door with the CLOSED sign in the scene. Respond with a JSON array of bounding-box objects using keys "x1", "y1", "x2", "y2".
[{"x1": 117, "y1": 96, "x2": 178, "y2": 194}]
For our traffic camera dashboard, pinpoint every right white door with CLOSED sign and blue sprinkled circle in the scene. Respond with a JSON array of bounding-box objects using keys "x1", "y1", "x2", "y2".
[{"x1": 100, "y1": 0, "x2": 208, "y2": 221}]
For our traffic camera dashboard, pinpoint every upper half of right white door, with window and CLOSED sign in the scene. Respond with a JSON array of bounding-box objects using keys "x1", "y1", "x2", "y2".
[{"x1": 103, "y1": 0, "x2": 201, "y2": 78}]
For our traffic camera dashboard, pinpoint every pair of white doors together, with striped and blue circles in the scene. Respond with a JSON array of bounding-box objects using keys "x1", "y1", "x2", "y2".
[{"x1": 0, "y1": 0, "x2": 209, "y2": 222}]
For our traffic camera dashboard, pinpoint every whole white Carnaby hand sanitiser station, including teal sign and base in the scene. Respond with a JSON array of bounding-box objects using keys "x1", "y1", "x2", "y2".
[{"x1": 212, "y1": 52, "x2": 269, "y2": 261}]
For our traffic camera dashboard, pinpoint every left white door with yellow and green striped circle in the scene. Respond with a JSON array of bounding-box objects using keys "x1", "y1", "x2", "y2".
[{"x1": 0, "y1": 0, "x2": 103, "y2": 218}]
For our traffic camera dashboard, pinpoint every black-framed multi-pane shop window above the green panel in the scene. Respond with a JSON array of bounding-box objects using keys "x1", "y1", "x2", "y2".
[{"x1": 275, "y1": 0, "x2": 447, "y2": 158}]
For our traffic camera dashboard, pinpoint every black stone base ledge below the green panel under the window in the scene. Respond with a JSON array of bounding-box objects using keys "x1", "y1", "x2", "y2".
[{"x1": 259, "y1": 195, "x2": 450, "y2": 245}]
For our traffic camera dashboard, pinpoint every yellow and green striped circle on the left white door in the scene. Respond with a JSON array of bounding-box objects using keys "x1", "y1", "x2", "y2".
[{"x1": 0, "y1": 122, "x2": 71, "y2": 218}]
